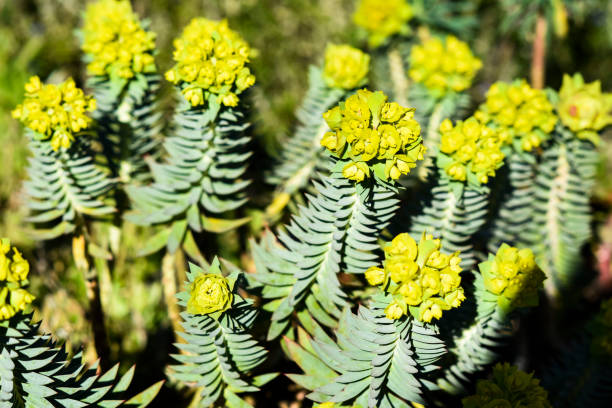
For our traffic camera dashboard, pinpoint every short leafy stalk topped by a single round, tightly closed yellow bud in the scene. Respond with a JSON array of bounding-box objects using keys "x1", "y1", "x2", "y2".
[{"x1": 170, "y1": 258, "x2": 276, "y2": 408}]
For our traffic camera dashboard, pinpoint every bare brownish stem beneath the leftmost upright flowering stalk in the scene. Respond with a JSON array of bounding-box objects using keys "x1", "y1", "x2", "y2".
[{"x1": 72, "y1": 234, "x2": 110, "y2": 371}]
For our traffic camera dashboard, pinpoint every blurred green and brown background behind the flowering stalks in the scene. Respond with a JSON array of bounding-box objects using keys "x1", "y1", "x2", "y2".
[{"x1": 0, "y1": 0, "x2": 612, "y2": 406}]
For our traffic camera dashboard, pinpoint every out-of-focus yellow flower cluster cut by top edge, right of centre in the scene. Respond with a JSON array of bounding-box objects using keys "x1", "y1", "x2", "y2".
[{"x1": 353, "y1": 0, "x2": 413, "y2": 47}]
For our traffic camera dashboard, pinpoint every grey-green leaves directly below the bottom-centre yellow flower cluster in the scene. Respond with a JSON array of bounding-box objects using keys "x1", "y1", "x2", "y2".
[{"x1": 285, "y1": 293, "x2": 446, "y2": 408}]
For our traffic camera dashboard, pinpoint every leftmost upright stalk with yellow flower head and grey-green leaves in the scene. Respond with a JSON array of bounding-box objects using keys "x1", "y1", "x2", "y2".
[{"x1": 13, "y1": 76, "x2": 115, "y2": 239}]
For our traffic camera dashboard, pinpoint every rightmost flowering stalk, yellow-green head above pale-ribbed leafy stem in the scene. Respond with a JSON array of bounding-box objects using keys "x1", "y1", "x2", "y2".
[{"x1": 528, "y1": 76, "x2": 612, "y2": 294}]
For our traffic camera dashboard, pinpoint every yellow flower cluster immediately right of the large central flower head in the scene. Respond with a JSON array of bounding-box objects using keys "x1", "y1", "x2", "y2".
[{"x1": 438, "y1": 117, "x2": 504, "y2": 184}]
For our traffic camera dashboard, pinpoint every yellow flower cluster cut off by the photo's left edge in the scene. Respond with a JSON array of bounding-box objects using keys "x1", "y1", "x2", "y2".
[{"x1": 0, "y1": 238, "x2": 34, "y2": 321}]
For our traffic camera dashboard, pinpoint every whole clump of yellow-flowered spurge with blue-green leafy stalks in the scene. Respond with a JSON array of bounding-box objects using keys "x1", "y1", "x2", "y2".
[{"x1": 0, "y1": 0, "x2": 612, "y2": 408}]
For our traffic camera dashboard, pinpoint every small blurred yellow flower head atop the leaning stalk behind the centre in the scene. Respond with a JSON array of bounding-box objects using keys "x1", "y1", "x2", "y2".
[{"x1": 323, "y1": 44, "x2": 370, "y2": 89}]
